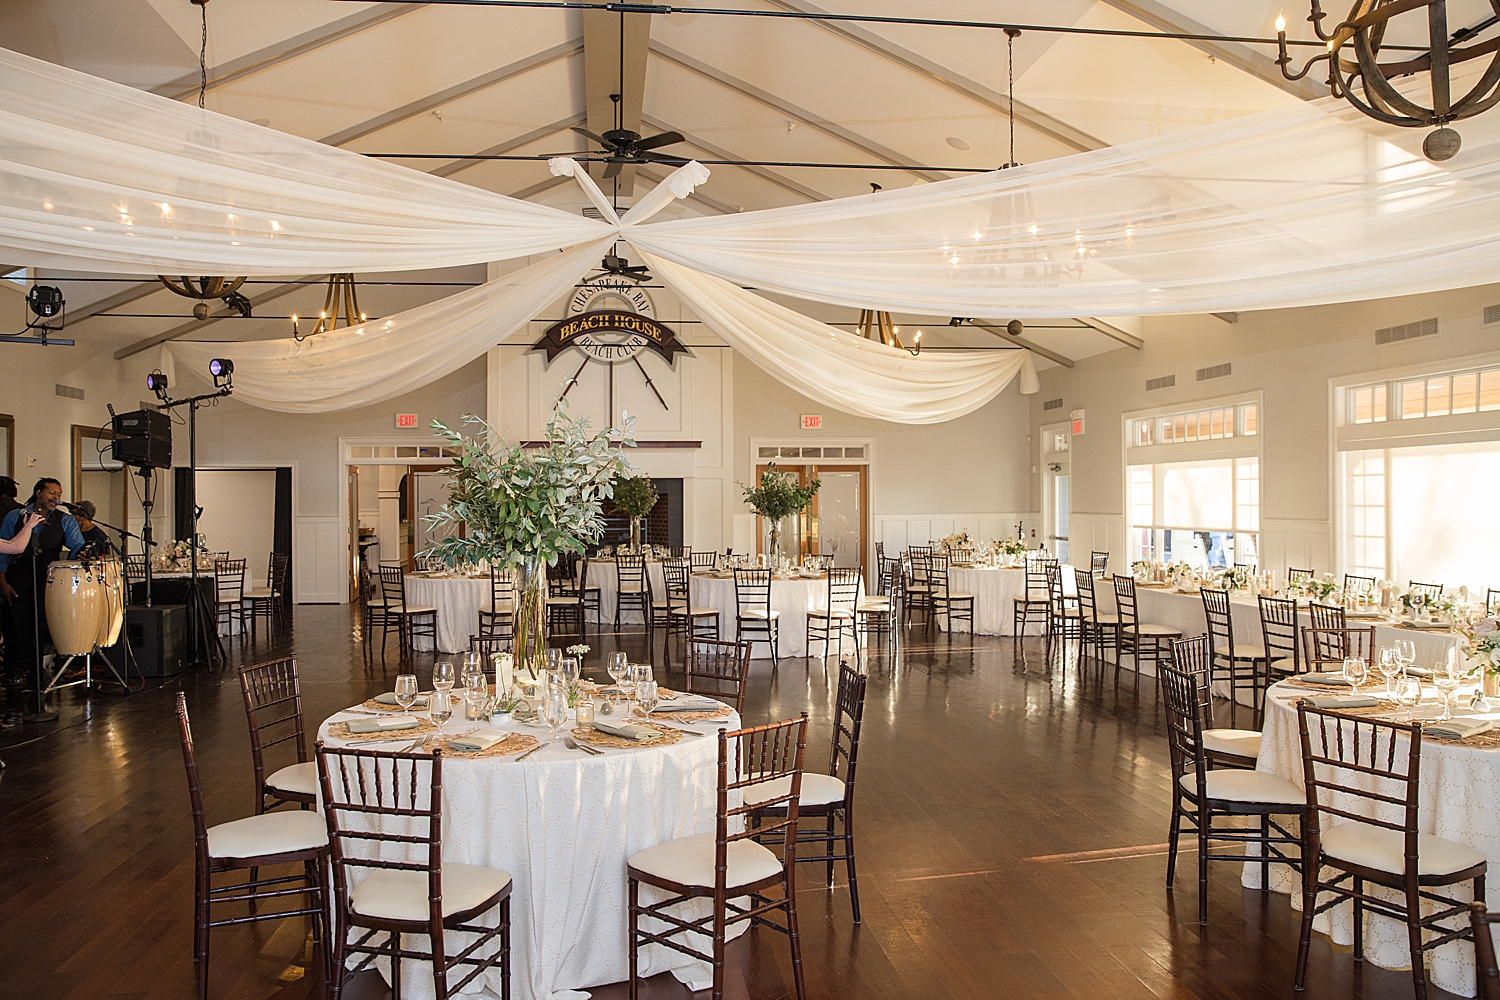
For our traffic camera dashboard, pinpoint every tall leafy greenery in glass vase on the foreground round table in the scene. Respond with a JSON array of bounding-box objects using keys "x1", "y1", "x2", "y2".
[{"x1": 423, "y1": 403, "x2": 635, "y2": 678}]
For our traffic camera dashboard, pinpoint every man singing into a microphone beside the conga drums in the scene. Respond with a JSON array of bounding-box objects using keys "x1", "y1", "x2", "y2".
[{"x1": 0, "y1": 478, "x2": 84, "y2": 687}]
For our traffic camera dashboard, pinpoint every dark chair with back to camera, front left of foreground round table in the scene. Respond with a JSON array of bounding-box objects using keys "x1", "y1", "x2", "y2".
[{"x1": 318, "y1": 745, "x2": 512, "y2": 1000}]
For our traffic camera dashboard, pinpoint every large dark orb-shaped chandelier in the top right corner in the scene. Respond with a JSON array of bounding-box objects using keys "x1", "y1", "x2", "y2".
[{"x1": 1277, "y1": 0, "x2": 1500, "y2": 160}]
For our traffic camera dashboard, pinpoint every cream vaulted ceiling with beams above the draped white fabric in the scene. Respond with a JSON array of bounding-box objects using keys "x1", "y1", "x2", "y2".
[{"x1": 0, "y1": 0, "x2": 1368, "y2": 367}]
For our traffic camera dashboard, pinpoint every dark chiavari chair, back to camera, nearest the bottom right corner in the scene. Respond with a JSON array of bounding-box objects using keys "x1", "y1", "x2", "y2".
[{"x1": 1296, "y1": 704, "x2": 1488, "y2": 1000}]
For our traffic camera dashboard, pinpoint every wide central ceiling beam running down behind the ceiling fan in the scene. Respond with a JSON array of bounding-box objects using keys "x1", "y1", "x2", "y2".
[{"x1": 584, "y1": 10, "x2": 651, "y2": 187}]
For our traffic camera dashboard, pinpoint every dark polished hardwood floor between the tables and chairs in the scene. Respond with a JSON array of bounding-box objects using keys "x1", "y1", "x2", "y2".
[{"x1": 0, "y1": 607, "x2": 1446, "y2": 1000}]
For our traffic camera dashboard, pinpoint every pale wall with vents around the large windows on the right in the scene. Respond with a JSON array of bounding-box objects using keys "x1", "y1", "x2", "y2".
[{"x1": 1031, "y1": 286, "x2": 1500, "y2": 573}]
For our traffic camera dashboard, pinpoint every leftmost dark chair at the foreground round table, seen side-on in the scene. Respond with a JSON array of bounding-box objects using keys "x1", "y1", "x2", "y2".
[{"x1": 177, "y1": 691, "x2": 333, "y2": 1000}]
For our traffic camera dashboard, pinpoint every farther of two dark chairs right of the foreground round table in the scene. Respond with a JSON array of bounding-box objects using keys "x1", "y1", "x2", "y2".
[{"x1": 746, "y1": 661, "x2": 869, "y2": 924}]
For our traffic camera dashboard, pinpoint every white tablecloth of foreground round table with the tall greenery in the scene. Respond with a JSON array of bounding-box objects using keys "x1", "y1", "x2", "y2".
[{"x1": 318, "y1": 712, "x2": 740, "y2": 1000}]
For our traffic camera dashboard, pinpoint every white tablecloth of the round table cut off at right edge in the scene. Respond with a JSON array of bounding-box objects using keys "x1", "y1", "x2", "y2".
[{"x1": 1242, "y1": 678, "x2": 1500, "y2": 997}]
